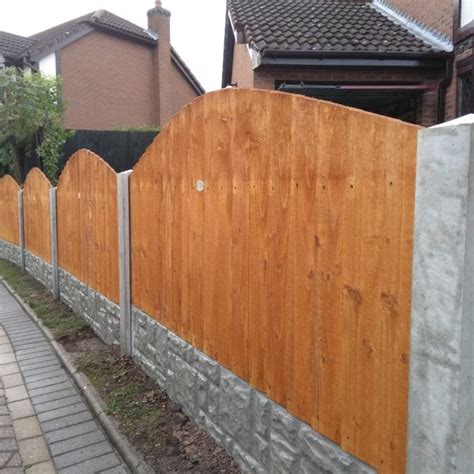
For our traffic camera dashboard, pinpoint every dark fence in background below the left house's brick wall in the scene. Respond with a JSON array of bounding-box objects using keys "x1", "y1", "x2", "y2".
[{"x1": 60, "y1": 130, "x2": 158, "y2": 173}]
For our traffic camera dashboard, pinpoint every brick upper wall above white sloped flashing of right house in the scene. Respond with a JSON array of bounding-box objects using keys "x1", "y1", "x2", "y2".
[{"x1": 386, "y1": 0, "x2": 454, "y2": 38}]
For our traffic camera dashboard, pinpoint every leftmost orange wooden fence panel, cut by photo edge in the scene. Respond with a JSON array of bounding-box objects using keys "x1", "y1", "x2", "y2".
[{"x1": 0, "y1": 175, "x2": 20, "y2": 245}]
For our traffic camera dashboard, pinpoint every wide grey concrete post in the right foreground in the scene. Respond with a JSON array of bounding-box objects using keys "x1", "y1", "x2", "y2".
[{"x1": 407, "y1": 115, "x2": 474, "y2": 474}]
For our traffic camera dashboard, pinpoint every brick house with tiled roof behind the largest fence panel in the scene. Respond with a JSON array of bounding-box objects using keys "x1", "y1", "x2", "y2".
[{"x1": 222, "y1": 0, "x2": 474, "y2": 126}]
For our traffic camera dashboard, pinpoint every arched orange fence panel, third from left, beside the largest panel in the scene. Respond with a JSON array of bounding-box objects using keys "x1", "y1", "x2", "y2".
[{"x1": 57, "y1": 150, "x2": 119, "y2": 303}]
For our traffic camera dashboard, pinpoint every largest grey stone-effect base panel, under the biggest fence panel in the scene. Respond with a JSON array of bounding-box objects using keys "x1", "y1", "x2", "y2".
[{"x1": 132, "y1": 308, "x2": 375, "y2": 474}]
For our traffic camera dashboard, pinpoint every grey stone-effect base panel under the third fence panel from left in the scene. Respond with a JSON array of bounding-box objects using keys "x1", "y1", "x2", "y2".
[{"x1": 59, "y1": 269, "x2": 120, "y2": 344}]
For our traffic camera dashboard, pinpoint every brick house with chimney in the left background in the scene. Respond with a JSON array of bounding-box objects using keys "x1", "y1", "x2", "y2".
[{"x1": 0, "y1": 1, "x2": 204, "y2": 130}]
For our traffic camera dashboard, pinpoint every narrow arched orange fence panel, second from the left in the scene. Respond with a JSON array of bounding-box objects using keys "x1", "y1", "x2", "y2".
[{"x1": 23, "y1": 168, "x2": 51, "y2": 262}]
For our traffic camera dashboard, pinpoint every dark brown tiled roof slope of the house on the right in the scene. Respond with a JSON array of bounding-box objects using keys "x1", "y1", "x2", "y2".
[{"x1": 228, "y1": 0, "x2": 440, "y2": 54}]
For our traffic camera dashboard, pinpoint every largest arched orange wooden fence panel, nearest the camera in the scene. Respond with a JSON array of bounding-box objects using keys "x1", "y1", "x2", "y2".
[{"x1": 131, "y1": 90, "x2": 418, "y2": 473}]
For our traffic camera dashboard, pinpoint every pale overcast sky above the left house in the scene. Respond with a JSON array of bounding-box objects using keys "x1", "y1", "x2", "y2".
[{"x1": 0, "y1": 0, "x2": 230, "y2": 91}]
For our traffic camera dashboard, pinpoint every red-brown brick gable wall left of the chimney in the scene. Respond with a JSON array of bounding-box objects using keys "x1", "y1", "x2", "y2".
[{"x1": 61, "y1": 31, "x2": 154, "y2": 130}]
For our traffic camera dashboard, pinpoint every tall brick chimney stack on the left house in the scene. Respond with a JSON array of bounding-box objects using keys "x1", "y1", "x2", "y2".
[{"x1": 148, "y1": 0, "x2": 173, "y2": 126}]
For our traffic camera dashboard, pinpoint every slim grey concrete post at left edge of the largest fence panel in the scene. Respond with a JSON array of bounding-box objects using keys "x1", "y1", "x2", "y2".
[{"x1": 117, "y1": 171, "x2": 132, "y2": 355}]
